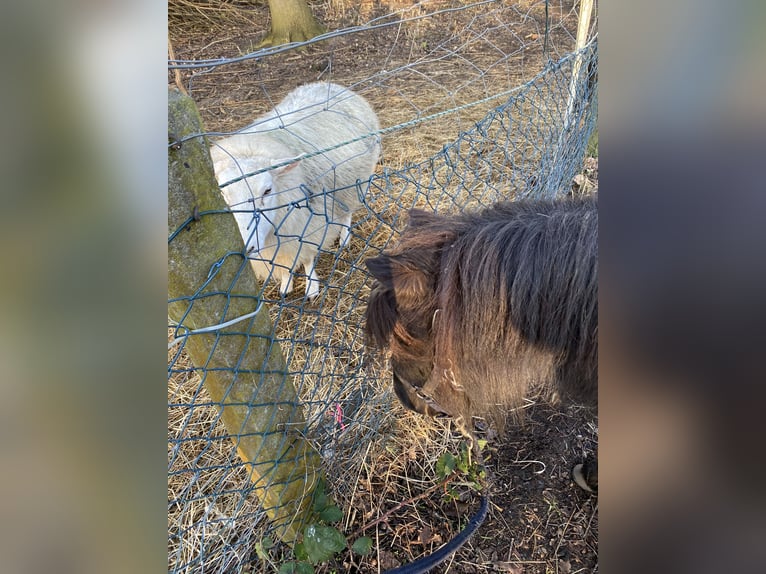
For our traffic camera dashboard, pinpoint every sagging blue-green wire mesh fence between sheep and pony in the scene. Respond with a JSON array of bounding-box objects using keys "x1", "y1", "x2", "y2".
[{"x1": 168, "y1": 1, "x2": 597, "y2": 572}]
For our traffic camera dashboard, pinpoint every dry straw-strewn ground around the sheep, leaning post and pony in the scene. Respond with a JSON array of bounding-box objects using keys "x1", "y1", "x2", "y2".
[{"x1": 168, "y1": 0, "x2": 597, "y2": 572}]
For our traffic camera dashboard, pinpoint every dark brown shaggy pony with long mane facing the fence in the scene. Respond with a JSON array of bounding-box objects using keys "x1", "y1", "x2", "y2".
[{"x1": 366, "y1": 196, "x2": 598, "y2": 490}]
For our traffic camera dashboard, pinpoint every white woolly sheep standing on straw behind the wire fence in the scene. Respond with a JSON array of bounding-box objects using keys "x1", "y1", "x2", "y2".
[{"x1": 210, "y1": 82, "x2": 380, "y2": 299}]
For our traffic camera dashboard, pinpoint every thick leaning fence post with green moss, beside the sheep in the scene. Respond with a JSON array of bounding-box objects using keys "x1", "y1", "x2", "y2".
[{"x1": 168, "y1": 90, "x2": 321, "y2": 544}]
